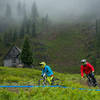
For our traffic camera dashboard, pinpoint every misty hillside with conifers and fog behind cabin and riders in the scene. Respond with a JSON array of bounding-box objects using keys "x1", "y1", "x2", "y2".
[{"x1": 0, "y1": 0, "x2": 100, "y2": 73}]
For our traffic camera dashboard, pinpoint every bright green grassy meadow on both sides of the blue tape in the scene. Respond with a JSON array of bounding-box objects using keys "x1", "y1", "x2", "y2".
[{"x1": 0, "y1": 67, "x2": 100, "y2": 100}]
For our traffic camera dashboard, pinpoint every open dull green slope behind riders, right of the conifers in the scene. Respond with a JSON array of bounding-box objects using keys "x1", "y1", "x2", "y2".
[{"x1": 37, "y1": 23, "x2": 99, "y2": 73}]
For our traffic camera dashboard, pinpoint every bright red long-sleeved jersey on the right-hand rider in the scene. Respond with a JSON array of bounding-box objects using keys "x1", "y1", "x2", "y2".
[{"x1": 81, "y1": 62, "x2": 94, "y2": 77}]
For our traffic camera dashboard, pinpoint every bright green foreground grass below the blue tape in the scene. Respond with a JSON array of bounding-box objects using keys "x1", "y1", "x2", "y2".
[{"x1": 0, "y1": 88, "x2": 100, "y2": 100}]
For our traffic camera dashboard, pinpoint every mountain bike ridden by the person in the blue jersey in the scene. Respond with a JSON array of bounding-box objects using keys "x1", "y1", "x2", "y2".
[{"x1": 38, "y1": 74, "x2": 61, "y2": 86}]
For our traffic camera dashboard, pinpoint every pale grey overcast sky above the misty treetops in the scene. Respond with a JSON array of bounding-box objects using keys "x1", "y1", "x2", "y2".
[{"x1": 0, "y1": 0, "x2": 100, "y2": 19}]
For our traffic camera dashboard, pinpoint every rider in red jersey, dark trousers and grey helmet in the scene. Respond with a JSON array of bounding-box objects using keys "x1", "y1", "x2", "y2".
[{"x1": 81, "y1": 59, "x2": 97, "y2": 86}]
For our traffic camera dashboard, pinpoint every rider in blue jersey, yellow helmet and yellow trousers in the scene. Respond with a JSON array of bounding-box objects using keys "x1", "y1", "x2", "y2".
[{"x1": 40, "y1": 62, "x2": 53, "y2": 85}]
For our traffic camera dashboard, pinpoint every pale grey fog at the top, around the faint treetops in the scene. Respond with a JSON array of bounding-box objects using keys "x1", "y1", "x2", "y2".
[{"x1": 0, "y1": 0, "x2": 100, "y2": 21}]
